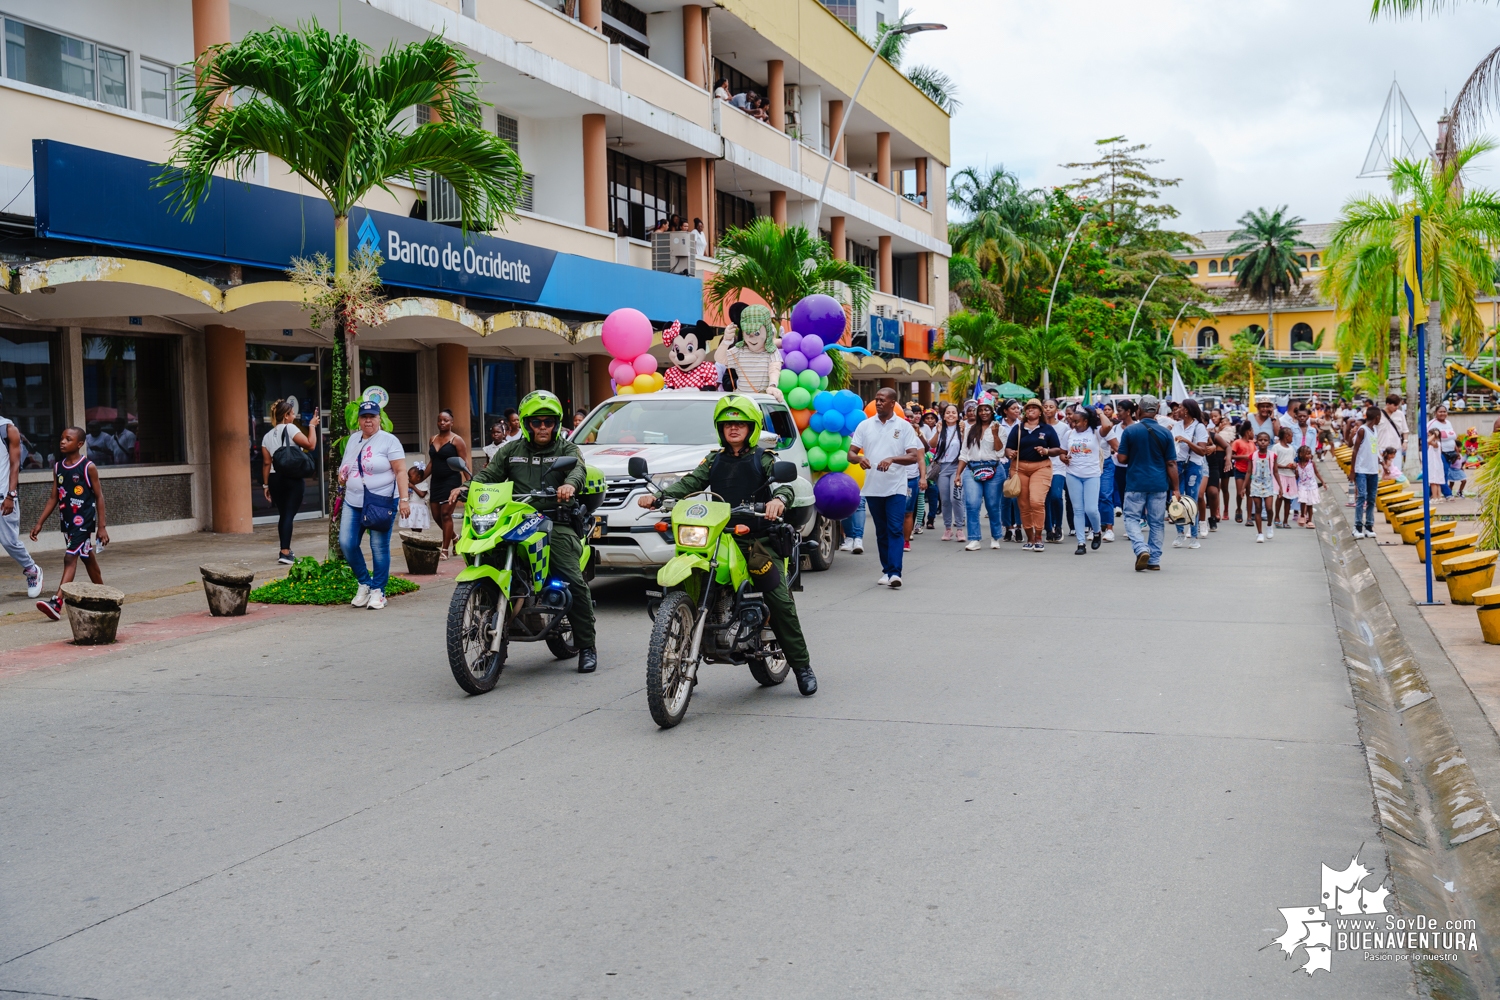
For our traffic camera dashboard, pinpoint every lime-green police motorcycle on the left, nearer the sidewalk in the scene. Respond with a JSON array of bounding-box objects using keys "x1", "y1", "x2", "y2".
[{"x1": 447, "y1": 456, "x2": 605, "y2": 694}]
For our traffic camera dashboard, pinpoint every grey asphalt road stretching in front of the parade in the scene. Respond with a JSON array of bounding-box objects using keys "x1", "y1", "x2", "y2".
[{"x1": 0, "y1": 525, "x2": 1410, "y2": 1000}]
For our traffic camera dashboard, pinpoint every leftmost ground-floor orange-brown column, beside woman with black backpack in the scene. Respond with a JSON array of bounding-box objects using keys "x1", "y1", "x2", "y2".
[{"x1": 204, "y1": 327, "x2": 252, "y2": 534}]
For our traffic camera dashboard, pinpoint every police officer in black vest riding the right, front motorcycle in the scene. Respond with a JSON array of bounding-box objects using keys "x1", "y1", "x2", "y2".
[{"x1": 638, "y1": 396, "x2": 818, "y2": 694}]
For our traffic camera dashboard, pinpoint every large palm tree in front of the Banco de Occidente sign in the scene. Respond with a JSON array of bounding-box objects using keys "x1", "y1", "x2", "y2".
[{"x1": 156, "y1": 21, "x2": 522, "y2": 452}]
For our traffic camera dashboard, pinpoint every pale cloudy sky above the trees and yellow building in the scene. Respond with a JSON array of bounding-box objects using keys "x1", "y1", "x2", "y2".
[{"x1": 902, "y1": 0, "x2": 1500, "y2": 232}]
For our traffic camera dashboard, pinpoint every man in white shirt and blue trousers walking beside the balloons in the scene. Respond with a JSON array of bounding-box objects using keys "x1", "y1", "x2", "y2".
[{"x1": 849, "y1": 388, "x2": 923, "y2": 589}]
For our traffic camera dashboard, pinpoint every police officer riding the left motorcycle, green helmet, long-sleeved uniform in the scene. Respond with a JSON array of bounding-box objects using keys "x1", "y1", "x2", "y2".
[{"x1": 450, "y1": 390, "x2": 599, "y2": 673}]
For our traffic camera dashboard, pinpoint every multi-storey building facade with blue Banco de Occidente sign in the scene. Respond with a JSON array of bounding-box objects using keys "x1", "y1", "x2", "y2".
[{"x1": 0, "y1": 0, "x2": 950, "y2": 538}]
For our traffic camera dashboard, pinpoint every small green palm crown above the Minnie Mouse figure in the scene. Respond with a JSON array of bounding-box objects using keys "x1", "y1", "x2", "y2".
[{"x1": 705, "y1": 216, "x2": 870, "y2": 322}]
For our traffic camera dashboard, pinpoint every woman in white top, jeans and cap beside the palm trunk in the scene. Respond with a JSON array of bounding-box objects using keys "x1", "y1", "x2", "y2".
[{"x1": 339, "y1": 400, "x2": 411, "y2": 612}]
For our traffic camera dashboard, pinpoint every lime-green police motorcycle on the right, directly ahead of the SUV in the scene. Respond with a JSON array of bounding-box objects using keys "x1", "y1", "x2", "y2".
[{"x1": 630, "y1": 457, "x2": 801, "y2": 729}]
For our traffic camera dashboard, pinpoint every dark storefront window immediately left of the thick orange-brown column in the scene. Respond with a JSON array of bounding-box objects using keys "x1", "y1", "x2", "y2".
[{"x1": 84, "y1": 334, "x2": 183, "y2": 465}]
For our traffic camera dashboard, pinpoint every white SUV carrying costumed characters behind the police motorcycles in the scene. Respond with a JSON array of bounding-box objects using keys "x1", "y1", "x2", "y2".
[{"x1": 573, "y1": 388, "x2": 839, "y2": 576}]
